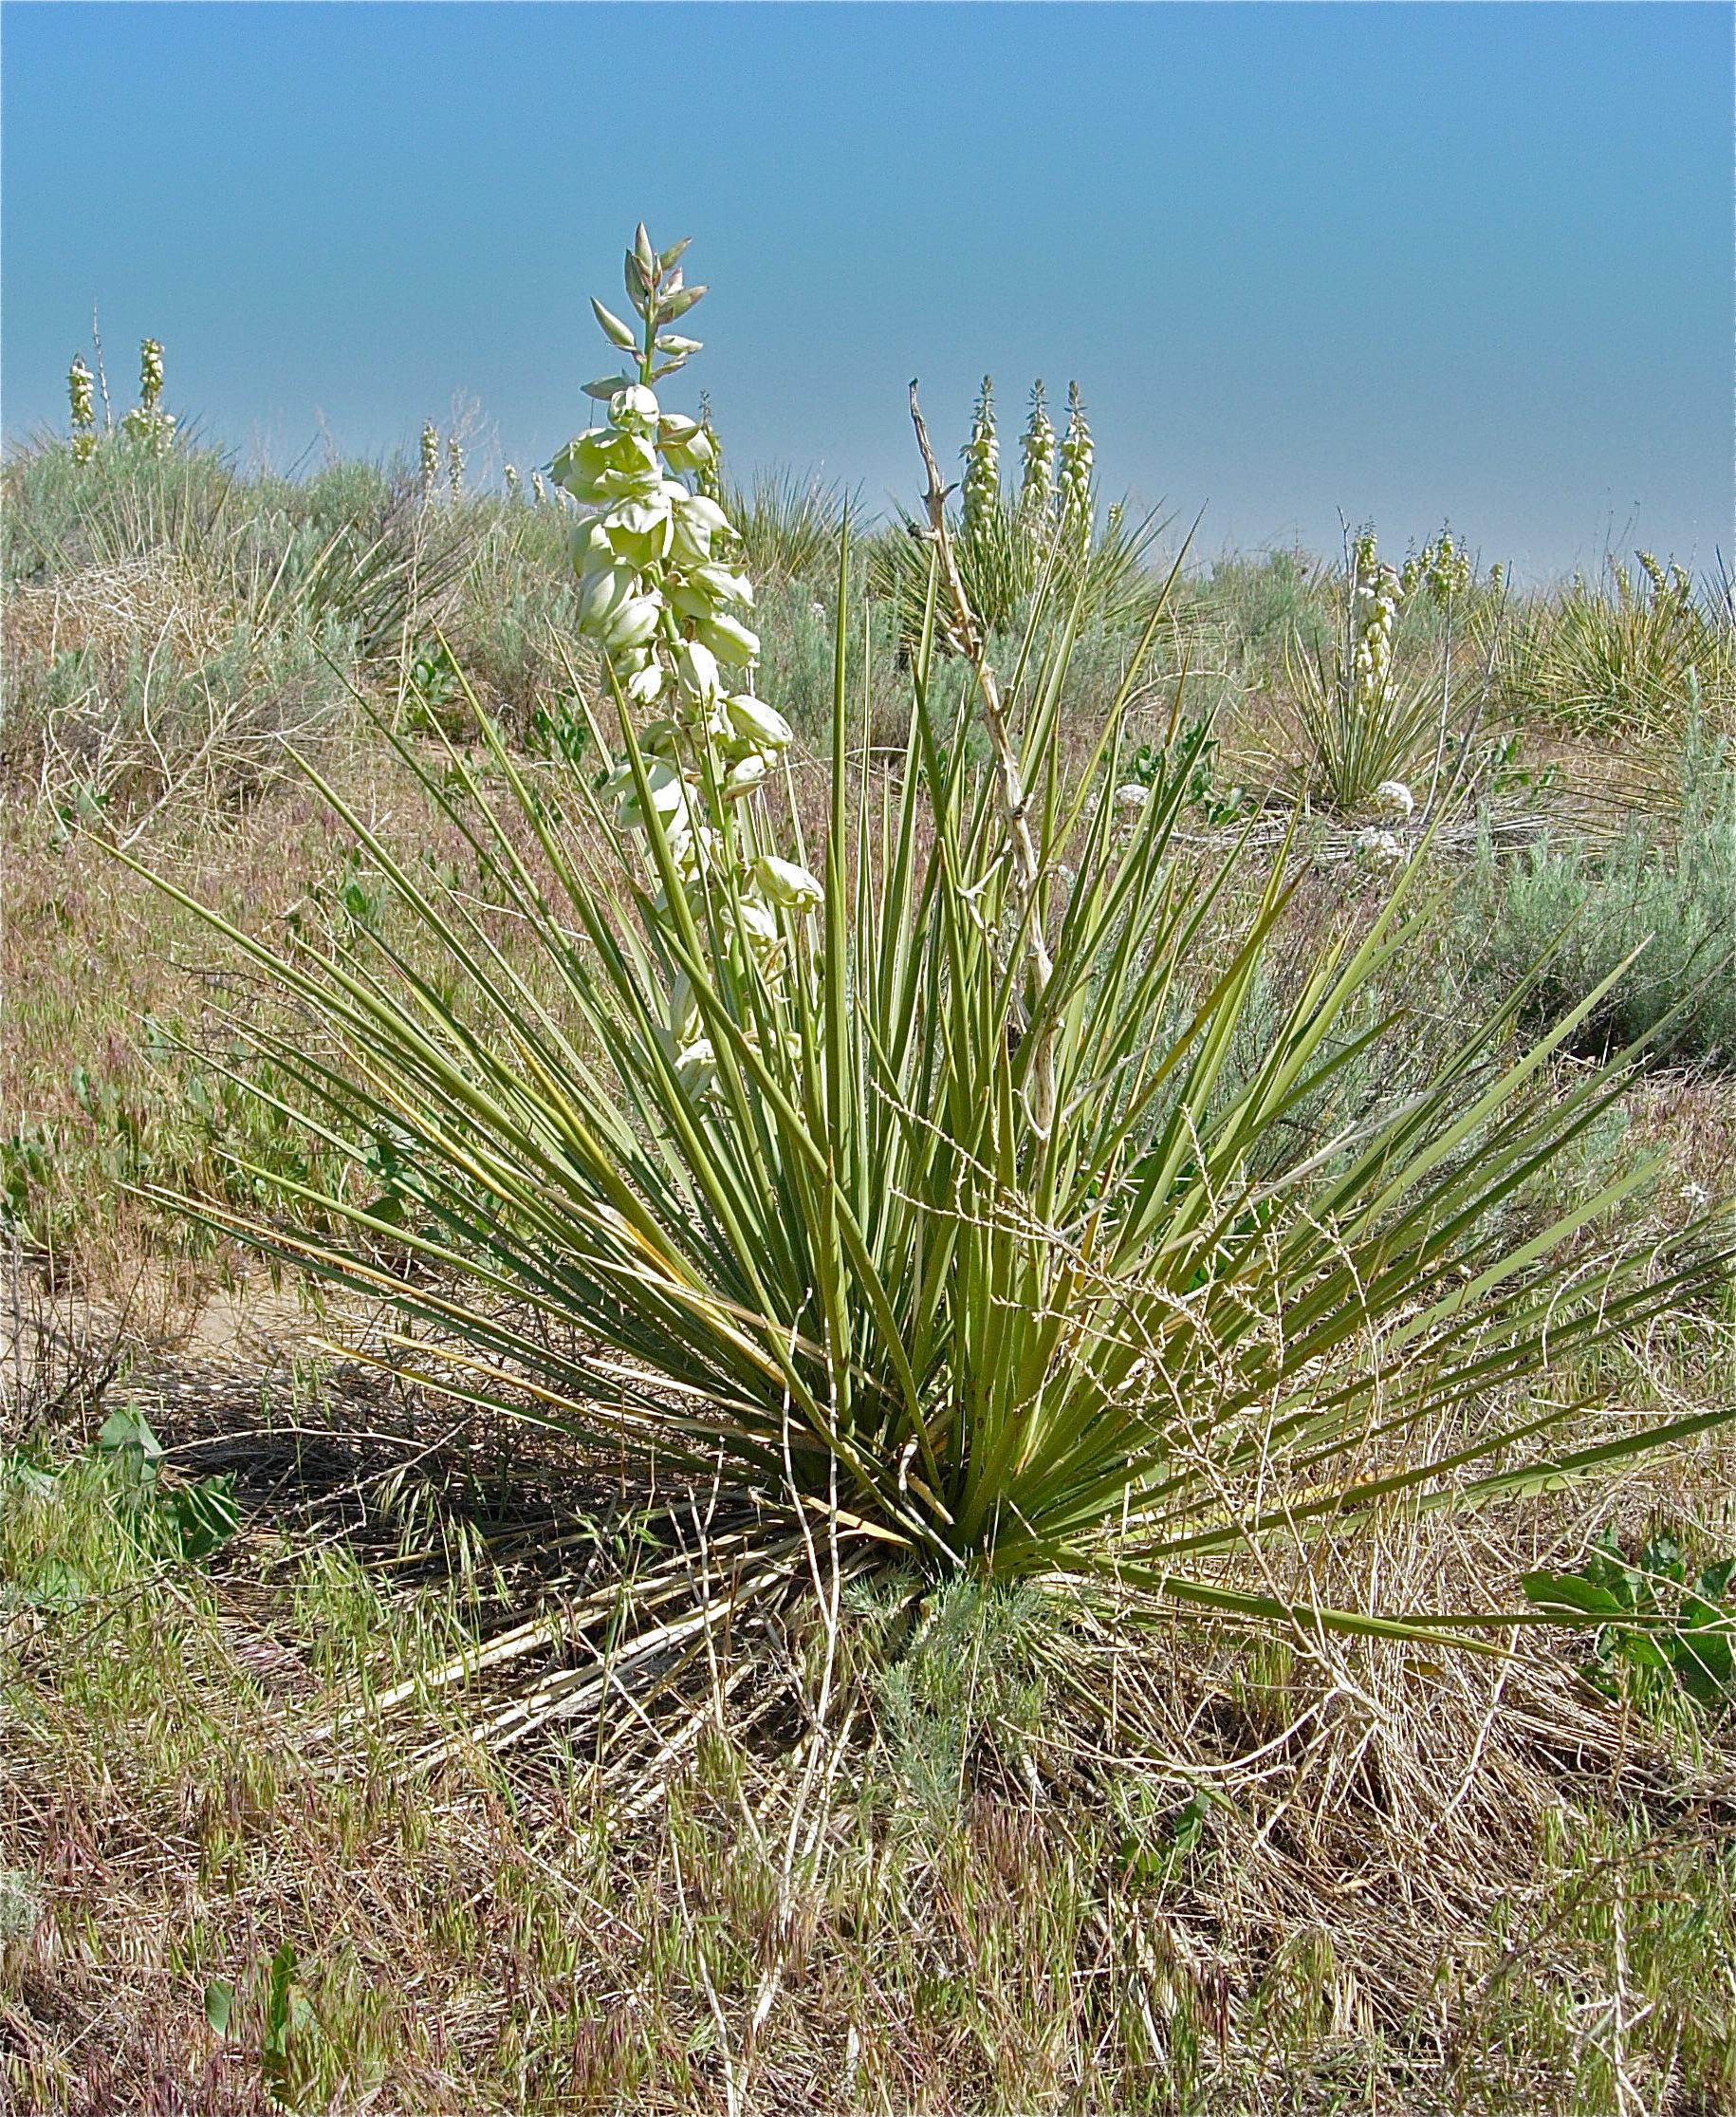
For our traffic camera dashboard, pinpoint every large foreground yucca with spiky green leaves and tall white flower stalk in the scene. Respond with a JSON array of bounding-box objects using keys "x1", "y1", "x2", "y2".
[{"x1": 128, "y1": 231, "x2": 1726, "y2": 1668}]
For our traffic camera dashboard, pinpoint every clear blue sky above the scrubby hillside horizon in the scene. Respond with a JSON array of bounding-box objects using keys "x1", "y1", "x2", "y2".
[{"x1": 0, "y1": 0, "x2": 1732, "y2": 574}]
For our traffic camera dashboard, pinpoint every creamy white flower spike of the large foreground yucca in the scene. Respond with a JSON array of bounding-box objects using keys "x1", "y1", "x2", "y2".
[{"x1": 552, "y1": 227, "x2": 822, "y2": 1094}]
